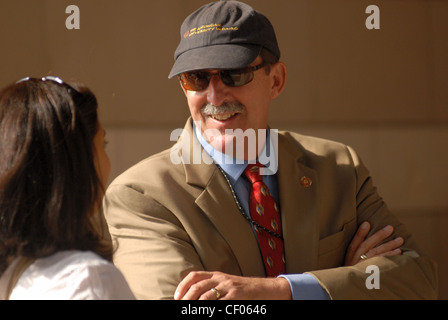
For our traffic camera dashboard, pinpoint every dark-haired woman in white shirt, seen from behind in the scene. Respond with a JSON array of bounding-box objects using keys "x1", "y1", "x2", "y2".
[{"x1": 0, "y1": 77, "x2": 134, "y2": 299}]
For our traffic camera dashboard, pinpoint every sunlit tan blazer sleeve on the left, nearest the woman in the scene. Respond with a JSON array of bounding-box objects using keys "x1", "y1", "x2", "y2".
[{"x1": 104, "y1": 184, "x2": 203, "y2": 300}]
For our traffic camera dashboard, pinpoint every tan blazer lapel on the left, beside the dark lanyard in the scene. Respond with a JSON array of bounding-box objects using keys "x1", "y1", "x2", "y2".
[{"x1": 181, "y1": 120, "x2": 265, "y2": 276}]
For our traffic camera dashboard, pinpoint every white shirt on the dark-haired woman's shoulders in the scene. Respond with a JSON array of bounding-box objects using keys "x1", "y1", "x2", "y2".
[{"x1": 10, "y1": 251, "x2": 135, "y2": 300}]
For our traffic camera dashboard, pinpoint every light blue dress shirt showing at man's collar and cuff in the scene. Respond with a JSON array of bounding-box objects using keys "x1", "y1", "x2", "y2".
[{"x1": 193, "y1": 123, "x2": 329, "y2": 300}]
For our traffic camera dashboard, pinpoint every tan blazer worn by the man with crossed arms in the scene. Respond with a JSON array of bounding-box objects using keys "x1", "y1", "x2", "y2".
[{"x1": 104, "y1": 120, "x2": 437, "y2": 299}]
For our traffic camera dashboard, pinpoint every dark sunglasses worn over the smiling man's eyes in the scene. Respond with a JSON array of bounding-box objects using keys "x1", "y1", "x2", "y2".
[{"x1": 179, "y1": 62, "x2": 267, "y2": 91}]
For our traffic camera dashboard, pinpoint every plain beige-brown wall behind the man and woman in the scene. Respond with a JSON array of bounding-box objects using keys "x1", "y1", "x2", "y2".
[{"x1": 0, "y1": 0, "x2": 448, "y2": 299}]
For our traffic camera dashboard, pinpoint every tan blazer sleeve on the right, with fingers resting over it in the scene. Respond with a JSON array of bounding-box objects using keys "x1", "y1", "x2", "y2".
[{"x1": 310, "y1": 148, "x2": 437, "y2": 299}]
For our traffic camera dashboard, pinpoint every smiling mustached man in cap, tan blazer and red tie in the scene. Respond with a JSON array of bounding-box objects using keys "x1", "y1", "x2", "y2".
[{"x1": 104, "y1": 1, "x2": 436, "y2": 299}]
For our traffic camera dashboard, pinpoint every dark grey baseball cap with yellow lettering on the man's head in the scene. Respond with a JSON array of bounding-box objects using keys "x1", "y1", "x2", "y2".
[{"x1": 168, "y1": 1, "x2": 280, "y2": 79}]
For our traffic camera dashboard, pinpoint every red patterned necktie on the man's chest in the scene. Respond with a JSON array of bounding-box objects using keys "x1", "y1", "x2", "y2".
[{"x1": 244, "y1": 163, "x2": 285, "y2": 277}]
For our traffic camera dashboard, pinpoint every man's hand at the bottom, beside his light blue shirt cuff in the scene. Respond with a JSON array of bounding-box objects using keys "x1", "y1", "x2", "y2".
[{"x1": 174, "y1": 271, "x2": 291, "y2": 300}]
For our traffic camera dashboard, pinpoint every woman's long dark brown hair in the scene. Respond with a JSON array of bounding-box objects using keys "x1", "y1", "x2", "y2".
[{"x1": 0, "y1": 79, "x2": 112, "y2": 274}]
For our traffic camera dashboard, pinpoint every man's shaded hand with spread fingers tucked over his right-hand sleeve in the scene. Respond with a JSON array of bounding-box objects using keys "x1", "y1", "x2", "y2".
[{"x1": 345, "y1": 222, "x2": 404, "y2": 266}]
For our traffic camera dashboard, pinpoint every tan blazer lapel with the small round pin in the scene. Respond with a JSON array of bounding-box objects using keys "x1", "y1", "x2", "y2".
[{"x1": 278, "y1": 134, "x2": 319, "y2": 273}]
